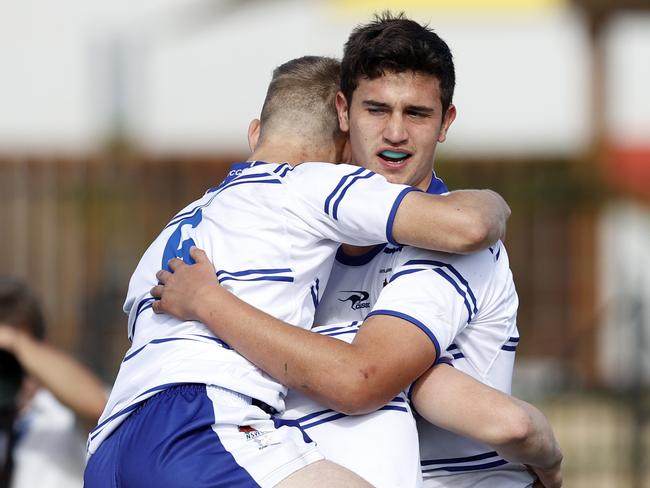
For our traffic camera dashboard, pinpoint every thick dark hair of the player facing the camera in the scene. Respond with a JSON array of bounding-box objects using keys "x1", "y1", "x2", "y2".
[{"x1": 341, "y1": 11, "x2": 456, "y2": 114}]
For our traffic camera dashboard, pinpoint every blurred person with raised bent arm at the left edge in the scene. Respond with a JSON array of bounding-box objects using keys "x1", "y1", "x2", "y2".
[{"x1": 0, "y1": 277, "x2": 106, "y2": 488}]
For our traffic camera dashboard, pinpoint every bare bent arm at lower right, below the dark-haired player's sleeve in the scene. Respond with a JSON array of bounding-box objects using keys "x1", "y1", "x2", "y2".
[{"x1": 412, "y1": 364, "x2": 562, "y2": 488}]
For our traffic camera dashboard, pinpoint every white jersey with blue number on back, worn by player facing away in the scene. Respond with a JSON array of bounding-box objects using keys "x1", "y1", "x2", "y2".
[{"x1": 89, "y1": 162, "x2": 414, "y2": 453}]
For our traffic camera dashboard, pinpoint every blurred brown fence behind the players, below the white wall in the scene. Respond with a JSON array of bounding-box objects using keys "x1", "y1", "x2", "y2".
[{"x1": 0, "y1": 154, "x2": 650, "y2": 488}]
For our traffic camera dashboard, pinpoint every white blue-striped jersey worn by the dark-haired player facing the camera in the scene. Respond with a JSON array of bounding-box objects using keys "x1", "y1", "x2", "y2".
[{"x1": 315, "y1": 239, "x2": 532, "y2": 487}]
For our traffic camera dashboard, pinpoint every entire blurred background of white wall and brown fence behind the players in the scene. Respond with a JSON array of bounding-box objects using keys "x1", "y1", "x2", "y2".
[{"x1": 0, "y1": 0, "x2": 650, "y2": 488}]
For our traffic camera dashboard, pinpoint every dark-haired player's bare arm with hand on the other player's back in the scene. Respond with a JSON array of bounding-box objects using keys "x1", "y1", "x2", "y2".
[{"x1": 151, "y1": 248, "x2": 436, "y2": 414}]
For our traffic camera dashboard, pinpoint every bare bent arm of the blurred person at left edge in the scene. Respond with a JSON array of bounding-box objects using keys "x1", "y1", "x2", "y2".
[{"x1": 0, "y1": 324, "x2": 106, "y2": 425}]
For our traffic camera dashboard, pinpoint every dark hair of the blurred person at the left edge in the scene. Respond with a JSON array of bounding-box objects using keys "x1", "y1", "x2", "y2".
[{"x1": 0, "y1": 277, "x2": 45, "y2": 340}]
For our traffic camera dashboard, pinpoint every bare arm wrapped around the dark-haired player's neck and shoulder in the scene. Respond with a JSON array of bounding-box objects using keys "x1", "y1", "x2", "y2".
[{"x1": 393, "y1": 190, "x2": 510, "y2": 254}]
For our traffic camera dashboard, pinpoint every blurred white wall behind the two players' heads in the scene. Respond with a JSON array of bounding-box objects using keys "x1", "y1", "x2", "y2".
[{"x1": 0, "y1": 0, "x2": 650, "y2": 155}]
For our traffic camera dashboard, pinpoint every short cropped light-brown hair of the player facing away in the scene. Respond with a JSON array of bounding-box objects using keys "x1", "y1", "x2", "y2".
[{"x1": 260, "y1": 56, "x2": 341, "y2": 142}]
